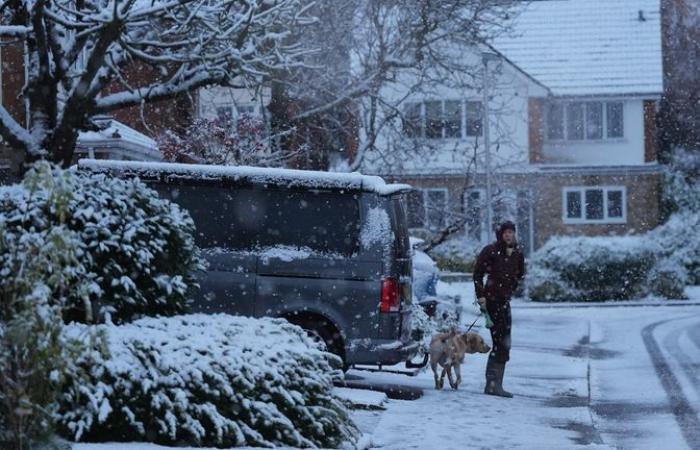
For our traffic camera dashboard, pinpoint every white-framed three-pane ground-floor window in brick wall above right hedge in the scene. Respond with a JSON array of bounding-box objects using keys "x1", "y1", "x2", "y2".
[{"x1": 563, "y1": 186, "x2": 627, "y2": 223}]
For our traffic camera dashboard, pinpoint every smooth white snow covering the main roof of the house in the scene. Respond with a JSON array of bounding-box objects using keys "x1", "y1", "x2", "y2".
[{"x1": 493, "y1": 0, "x2": 663, "y2": 96}]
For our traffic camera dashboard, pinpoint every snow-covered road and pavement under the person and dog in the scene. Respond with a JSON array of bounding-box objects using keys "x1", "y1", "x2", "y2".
[{"x1": 350, "y1": 286, "x2": 700, "y2": 450}]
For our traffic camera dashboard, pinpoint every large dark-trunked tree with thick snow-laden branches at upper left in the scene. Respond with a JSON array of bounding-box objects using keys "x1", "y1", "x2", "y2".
[{"x1": 0, "y1": 0, "x2": 312, "y2": 165}]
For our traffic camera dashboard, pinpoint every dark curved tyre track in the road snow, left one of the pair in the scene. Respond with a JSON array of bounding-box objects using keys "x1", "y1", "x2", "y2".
[{"x1": 642, "y1": 316, "x2": 700, "y2": 449}]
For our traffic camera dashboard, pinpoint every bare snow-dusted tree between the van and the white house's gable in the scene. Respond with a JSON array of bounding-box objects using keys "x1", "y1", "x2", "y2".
[{"x1": 270, "y1": 0, "x2": 524, "y2": 170}]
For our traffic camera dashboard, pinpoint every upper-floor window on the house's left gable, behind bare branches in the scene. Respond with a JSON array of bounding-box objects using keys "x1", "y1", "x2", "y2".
[{"x1": 402, "y1": 100, "x2": 482, "y2": 139}]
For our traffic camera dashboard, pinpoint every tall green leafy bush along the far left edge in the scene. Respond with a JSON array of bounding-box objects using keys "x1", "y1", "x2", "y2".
[{"x1": 0, "y1": 165, "x2": 87, "y2": 450}]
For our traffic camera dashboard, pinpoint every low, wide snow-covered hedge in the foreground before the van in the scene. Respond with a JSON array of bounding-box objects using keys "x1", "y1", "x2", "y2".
[{"x1": 59, "y1": 314, "x2": 358, "y2": 448}]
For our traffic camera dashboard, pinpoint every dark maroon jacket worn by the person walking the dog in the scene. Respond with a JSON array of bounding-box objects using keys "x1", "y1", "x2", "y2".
[{"x1": 474, "y1": 229, "x2": 525, "y2": 302}]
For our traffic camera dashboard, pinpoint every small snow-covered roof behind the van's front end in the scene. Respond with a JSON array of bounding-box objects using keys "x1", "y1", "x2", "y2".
[{"x1": 77, "y1": 118, "x2": 163, "y2": 161}]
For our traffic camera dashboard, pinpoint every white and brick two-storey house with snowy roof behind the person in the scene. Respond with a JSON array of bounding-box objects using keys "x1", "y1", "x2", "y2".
[{"x1": 362, "y1": 0, "x2": 663, "y2": 252}]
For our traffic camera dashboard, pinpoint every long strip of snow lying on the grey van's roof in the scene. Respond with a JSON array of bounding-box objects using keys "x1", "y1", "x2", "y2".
[{"x1": 78, "y1": 159, "x2": 412, "y2": 195}]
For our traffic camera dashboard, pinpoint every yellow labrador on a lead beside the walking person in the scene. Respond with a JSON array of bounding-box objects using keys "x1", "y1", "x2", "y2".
[{"x1": 430, "y1": 331, "x2": 491, "y2": 389}]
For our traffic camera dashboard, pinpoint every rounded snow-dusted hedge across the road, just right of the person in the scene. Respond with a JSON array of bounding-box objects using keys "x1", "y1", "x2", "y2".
[{"x1": 525, "y1": 235, "x2": 687, "y2": 301}]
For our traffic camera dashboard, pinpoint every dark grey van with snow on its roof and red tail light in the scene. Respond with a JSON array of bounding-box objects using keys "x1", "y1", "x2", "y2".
[{"x1": 79, "y1": 160, "x2": 418, "y2": 365}]
